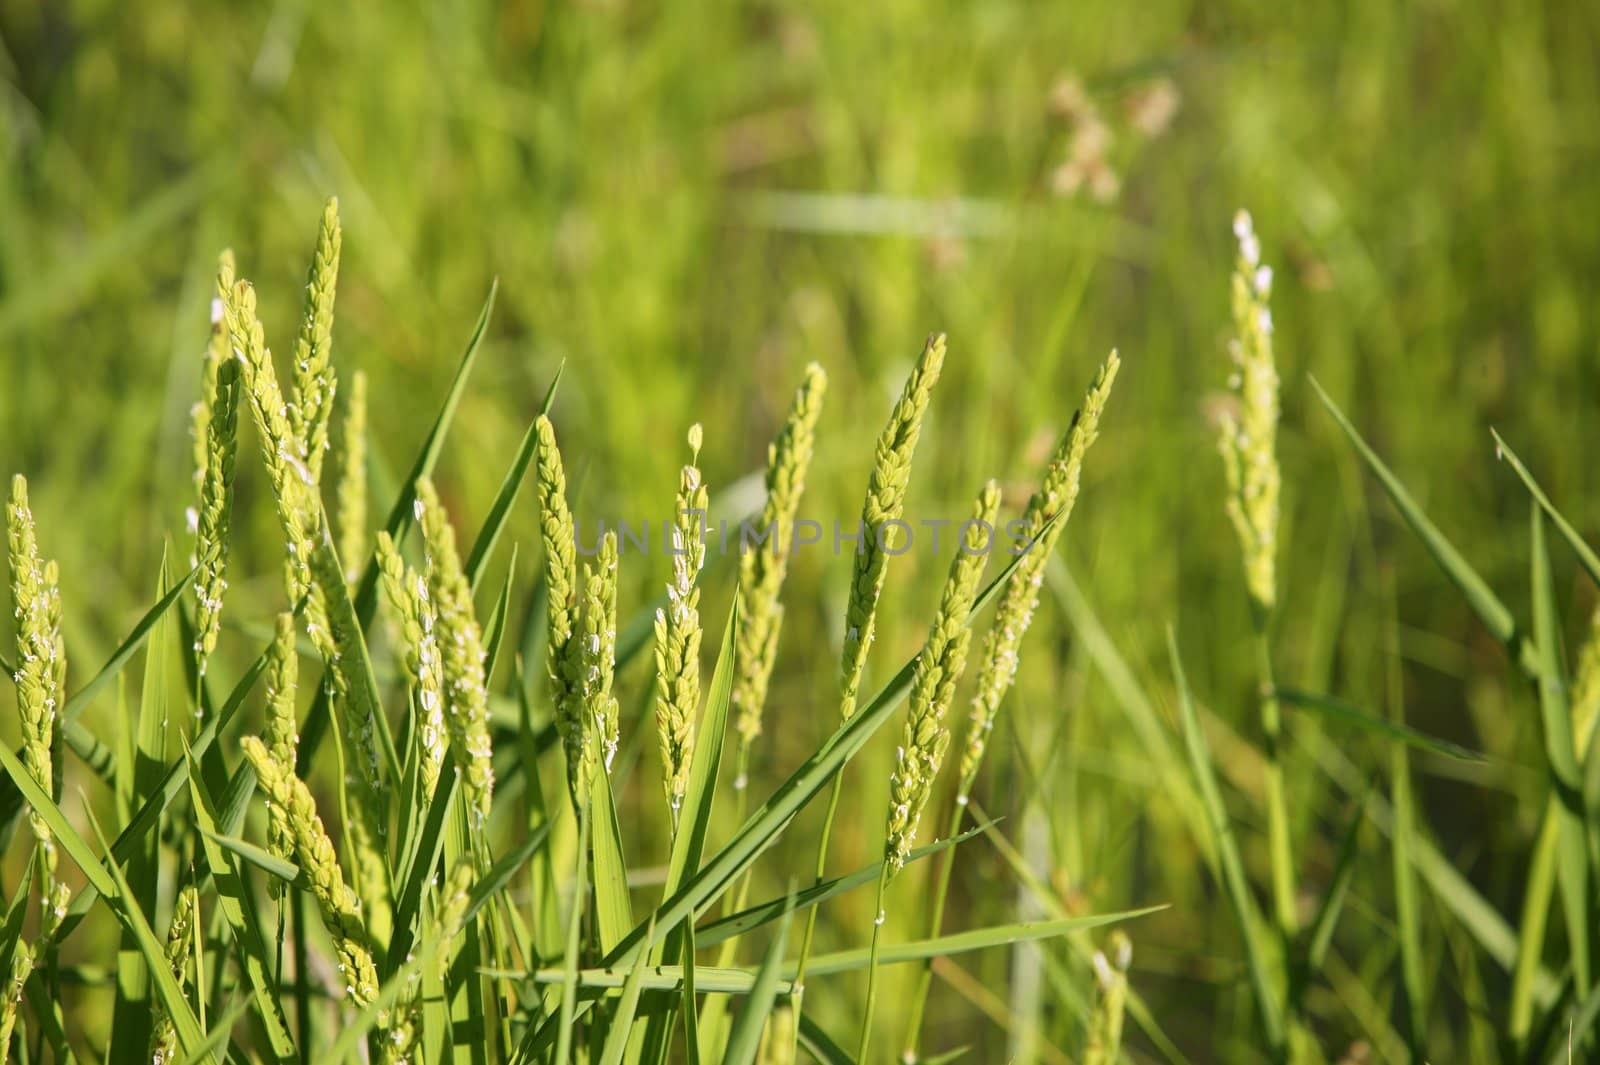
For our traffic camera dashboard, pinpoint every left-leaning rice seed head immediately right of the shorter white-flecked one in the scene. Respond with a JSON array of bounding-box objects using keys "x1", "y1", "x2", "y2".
[{"x1": 416, "y1": 477, "x2": 494, "y2": 828}]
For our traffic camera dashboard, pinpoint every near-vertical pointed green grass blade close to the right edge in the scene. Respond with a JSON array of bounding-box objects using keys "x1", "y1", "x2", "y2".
[{"x1": 1530, "y1": 504, "x2": 1590, "y2": 998}]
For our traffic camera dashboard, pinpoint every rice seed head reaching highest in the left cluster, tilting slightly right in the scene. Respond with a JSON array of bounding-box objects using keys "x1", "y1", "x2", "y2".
[{"x1": 290, "y1": 197, "x2": 342, "y2": 483}]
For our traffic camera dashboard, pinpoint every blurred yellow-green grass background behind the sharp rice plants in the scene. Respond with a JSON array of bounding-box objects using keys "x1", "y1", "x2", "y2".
[{"x1": 0, "y1": 0, "x2": 1600, "y2": 1060}]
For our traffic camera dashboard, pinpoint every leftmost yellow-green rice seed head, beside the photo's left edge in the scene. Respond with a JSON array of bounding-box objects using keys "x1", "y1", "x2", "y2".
[{"x1": 5, "y1": 475, "x2": 66, "y2": 844}]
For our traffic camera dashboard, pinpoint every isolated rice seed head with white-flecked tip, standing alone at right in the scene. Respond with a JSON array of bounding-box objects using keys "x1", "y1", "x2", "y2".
[{"x1": 1219, "y1": 211, "x2": 1280, "y2": 622}]
